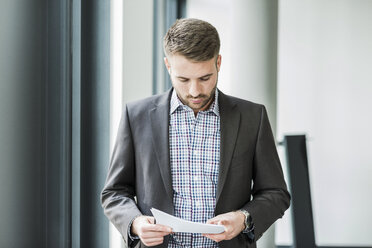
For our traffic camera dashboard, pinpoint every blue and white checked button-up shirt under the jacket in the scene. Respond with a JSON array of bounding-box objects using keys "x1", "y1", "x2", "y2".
[{"x1": 168, "y1": 89, "x2": 220, "y2": 248}]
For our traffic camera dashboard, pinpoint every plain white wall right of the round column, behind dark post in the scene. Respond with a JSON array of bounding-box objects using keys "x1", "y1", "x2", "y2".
[{"x1": 277, "y1": 0, "x2": 372, "y2": 246}]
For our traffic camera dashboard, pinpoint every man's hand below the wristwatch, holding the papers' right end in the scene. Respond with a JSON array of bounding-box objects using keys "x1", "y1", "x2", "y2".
[{"x1": 203, "y1": 211, "x2": 245, "y2": 242}]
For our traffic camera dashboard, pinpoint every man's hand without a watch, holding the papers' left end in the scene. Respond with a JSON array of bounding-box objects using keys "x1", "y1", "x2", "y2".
[{"x1": 131, "y1": 216, "x2": 172, "y2": 246}]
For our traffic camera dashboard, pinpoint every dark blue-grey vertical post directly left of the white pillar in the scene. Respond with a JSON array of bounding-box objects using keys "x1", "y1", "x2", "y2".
[{"x1": 80, "y1": 0, "x2": 110, "y2": 248}]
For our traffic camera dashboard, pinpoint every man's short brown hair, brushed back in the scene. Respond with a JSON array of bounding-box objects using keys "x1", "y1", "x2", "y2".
[{"x1": 163, "y1": 18, "x2": 220, "y2": 61}]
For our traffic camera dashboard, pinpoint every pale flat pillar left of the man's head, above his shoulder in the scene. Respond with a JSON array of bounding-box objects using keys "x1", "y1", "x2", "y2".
[{"x1": 123, "y1": 0, "x2": 153, "y2": 102}]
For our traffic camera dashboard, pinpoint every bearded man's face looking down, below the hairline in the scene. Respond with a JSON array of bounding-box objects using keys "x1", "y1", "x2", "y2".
[{"x1": 164, "y1": 54, "x2": 221, "y2": 114}]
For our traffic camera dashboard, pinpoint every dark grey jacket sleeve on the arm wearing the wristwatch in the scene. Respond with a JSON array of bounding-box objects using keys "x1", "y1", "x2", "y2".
[{"x1": 244, "y1": 106, "x2": 290, "y2": 241}]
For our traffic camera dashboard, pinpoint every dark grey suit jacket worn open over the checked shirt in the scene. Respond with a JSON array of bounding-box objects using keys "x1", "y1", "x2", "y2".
[{"x1": 101, "y1": 89, "x2": 290, "y2": 248}]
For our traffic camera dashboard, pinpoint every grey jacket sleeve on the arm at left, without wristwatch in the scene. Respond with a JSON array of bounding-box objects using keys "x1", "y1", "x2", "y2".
[{"x1": 101, "y1": 104, "x2": 141, "y2": 247}]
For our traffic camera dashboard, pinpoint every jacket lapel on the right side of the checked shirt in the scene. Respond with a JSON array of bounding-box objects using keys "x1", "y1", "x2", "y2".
[{"x1": 216, "y1": 91, "x2": 240, "y2": 203}]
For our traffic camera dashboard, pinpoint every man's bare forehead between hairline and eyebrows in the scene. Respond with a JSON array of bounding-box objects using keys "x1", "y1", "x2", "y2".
[{"x1": 168, "y1": 54, "x2": 216, "y2": 78}]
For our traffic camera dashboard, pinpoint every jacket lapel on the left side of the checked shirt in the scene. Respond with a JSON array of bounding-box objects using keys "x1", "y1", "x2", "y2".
[{"x1": 149, "y1": 90, "x2": 173, "y2": 202}]
